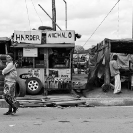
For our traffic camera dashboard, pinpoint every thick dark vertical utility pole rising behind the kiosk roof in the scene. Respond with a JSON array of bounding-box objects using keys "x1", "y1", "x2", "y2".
[{"x1": 52, "y1": 0, "x2": 56, "y2": 31}]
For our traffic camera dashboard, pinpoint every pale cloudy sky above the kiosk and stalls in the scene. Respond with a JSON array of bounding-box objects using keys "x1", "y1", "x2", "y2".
[{"x1": 0, "y1": 0, "x2": 133, "y2": 49}]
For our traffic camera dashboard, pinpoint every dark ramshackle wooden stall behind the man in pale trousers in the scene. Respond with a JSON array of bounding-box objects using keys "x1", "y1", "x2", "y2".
[{"x1": 86, "y1": 38, "x2": 133, "y2": 91}]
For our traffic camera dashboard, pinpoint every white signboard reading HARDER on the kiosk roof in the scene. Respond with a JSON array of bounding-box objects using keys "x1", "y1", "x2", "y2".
[{"x1": 14, "y1": 30, "x2": 42, "y2": 44}]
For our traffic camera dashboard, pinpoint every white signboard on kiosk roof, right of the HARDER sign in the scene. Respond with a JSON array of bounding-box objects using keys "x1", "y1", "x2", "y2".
[{"x1": 46, "y1": 31, "x2": 75, "y2": 43}]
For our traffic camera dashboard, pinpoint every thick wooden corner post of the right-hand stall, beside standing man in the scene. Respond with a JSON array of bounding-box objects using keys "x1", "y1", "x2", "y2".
[{"x1": 104, "y1": 40, "x2": 110, "y2": 86}]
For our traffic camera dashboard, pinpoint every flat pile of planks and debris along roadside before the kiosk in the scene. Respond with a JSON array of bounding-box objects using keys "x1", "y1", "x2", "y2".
[{"x1": 17, "y1": 96, "x2": 88, "y2": 107}]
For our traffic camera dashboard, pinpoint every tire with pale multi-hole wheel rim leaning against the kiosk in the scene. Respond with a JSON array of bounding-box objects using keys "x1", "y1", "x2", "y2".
[{"x1": 26, "y1": 77, "x2": 42, "y2": 95}]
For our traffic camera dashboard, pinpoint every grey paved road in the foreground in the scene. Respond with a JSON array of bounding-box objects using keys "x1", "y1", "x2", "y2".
[{"x1": 0, "y1": 106, "x2": 133, "y2": 133}]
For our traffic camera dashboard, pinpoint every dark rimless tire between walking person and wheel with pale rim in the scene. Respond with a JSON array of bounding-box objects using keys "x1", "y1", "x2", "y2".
[{"x1": 15, "y1": 82, "x2": 26, "y2": 97}]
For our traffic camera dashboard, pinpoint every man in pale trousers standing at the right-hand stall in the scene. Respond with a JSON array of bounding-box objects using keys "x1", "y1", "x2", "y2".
[{"x1": 110, "y1": 55, "x2": 121, "y2": 94}]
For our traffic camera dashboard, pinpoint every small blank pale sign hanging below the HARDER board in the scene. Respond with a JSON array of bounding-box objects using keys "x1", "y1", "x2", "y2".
[{"x1": 23, "y1": 48, "x2": 38, "y2": 57}]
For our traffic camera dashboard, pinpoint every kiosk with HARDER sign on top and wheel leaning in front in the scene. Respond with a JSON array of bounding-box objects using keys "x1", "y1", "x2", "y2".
[{"x1": 12, "y1": 30, "x2": 75, "y2": 94}]
